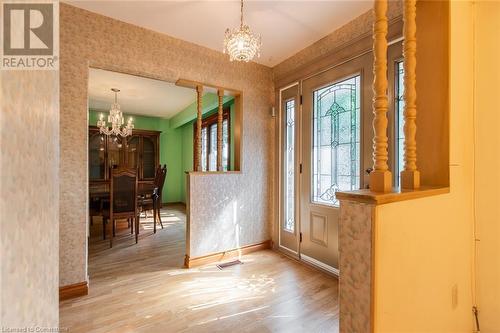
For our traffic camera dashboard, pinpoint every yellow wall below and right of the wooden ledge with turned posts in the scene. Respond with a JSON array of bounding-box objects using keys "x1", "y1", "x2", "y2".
[{"x1": 374, "y1": 1, "x2": 474, "y2": 332}]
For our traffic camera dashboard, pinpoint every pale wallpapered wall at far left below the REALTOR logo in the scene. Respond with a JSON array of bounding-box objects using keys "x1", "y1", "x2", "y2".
[{"x1": 0, "y1": 70, "x2": 59, "y2": 331}]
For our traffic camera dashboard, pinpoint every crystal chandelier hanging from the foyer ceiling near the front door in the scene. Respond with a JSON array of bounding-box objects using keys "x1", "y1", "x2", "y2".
[{"x1": 224, "y1": 0, "x2": 261, "y2": 62}]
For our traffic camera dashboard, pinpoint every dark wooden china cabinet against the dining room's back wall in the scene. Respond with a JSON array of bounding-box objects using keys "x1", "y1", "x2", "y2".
[{"x1": 89, "y1": 126, "x2": 161, "y2": 184}]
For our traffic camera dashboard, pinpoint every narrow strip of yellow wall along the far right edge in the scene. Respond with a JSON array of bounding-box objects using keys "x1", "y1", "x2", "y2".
[{"x1": 474, "y1": 1, "x2": 500, "y2": 333}]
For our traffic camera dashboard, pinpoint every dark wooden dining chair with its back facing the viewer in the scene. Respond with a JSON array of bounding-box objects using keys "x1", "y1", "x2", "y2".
[{"x1": 103, "y1": 168, "x2": 140, "y2": 247}]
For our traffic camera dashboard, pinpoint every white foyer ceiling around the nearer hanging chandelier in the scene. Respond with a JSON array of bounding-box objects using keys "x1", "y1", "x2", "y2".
[{"x1": 67, "y1": 0, "x2": 373, "y2": 67}]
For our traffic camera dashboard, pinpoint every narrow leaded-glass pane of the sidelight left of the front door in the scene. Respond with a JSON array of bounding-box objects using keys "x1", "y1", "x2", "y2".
[{"x1": 284, "y1": 99, "x2": 295, "y2": 232}]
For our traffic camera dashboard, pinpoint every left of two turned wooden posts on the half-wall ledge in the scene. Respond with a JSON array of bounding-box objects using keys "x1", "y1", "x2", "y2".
[{"x1": 370, "y1": 0, "x2": 392, "y2": 192}]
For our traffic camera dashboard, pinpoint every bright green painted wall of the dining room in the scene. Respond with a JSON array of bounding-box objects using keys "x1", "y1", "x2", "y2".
[{"x1": 89, "y1": 93, "x2": 234, "y2": 203}]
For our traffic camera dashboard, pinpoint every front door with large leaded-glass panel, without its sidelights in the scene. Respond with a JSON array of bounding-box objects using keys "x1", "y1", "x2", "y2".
[{"x1": 300, "y1": 56, "x2": 372, "y2": 274}]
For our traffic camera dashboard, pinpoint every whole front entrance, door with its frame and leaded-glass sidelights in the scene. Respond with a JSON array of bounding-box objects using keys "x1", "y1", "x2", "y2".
[{"x1": 279, "y1": 42, "x2": 401, "y2": 274}]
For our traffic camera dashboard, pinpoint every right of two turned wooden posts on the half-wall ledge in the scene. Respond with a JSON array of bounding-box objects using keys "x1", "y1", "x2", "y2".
[{"x1": 401, "y1": 0, "x2": 420, "y2": 189}]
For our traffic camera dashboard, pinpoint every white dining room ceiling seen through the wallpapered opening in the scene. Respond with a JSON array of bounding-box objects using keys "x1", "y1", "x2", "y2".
[{"x1": 89, "y1": 68, "x2": 196, "y2": 118}]
